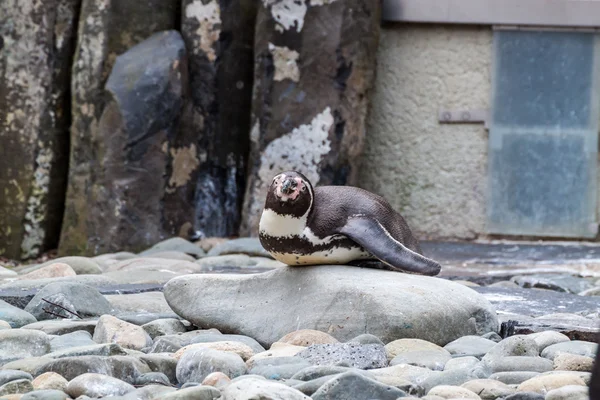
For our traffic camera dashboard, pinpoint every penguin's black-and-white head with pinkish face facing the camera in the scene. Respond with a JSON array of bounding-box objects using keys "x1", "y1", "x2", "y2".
[{"x1": 265, "y1": 171, "x2": 314, "y2": 217}]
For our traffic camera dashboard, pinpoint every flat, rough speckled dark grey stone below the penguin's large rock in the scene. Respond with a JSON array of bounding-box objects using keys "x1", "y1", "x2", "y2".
[{"x1": 297, "y1": 343, "x2": 387, "y2": 369}]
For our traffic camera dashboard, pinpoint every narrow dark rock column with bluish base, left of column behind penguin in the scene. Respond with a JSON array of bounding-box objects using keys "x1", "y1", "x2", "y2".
[{"x1": 179, "y1": 0, "x2": 260, "y2": 236}]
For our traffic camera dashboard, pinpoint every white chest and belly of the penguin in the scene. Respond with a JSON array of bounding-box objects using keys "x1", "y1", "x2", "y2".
[{"x1": 259, "y1": 209, "x2": 370, "y2": 265}]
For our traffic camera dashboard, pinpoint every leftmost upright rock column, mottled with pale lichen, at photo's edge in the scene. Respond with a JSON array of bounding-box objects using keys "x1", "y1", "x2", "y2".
[{"x1": 0, "y1": 0, "x2": 81, "y2": 259}]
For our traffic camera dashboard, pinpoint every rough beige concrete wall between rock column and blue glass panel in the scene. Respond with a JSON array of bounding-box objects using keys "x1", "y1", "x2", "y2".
[{"x1": 360, "y1": 24, "x2": 492, "y2": 239}]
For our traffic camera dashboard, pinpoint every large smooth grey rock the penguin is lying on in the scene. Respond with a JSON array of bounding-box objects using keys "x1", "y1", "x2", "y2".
[{"x1": 164, "y1": 265, "x2": 498, "y2": 346}]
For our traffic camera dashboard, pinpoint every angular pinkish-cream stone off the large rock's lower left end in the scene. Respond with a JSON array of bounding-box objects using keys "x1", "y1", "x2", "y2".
[{"x1": 93, "y1": 315, "x2": 152, "y2": 350}]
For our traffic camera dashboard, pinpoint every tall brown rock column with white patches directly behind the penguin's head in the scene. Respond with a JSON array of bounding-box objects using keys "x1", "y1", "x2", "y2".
[{"x1": 240, "y1": 0, "x2": 381, "y2": 236}]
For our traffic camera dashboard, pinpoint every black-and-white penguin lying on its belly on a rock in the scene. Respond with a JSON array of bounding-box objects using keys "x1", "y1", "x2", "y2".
[{"x1": 258, "y1": 171, "x2": 441, "y2": 276}]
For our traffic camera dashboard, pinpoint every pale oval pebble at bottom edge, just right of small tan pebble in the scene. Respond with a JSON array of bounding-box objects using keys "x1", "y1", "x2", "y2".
[{"x1": 66, "y1": 373, "x2": 135, "y2": 398}]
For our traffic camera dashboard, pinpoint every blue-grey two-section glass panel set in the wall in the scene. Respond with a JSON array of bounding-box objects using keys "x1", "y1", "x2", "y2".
[{"x1": 487, "y1": 31, "x2": 599, "y2": 237}]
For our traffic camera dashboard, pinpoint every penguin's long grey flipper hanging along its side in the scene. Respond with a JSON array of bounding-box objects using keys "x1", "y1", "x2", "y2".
[{"x1": 338, "y1": 216, "x2": 442, "y2": 276}]
